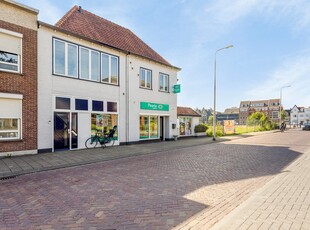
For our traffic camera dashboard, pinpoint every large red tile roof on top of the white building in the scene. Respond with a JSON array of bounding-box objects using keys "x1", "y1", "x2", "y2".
[{"x1": 55, "y1": 6, "x2": 173, "y2": 67}]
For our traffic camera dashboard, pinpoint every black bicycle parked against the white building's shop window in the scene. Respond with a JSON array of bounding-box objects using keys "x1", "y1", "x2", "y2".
[{"x1": 85, "y1": 125, "x2": 117, "y2": 149}]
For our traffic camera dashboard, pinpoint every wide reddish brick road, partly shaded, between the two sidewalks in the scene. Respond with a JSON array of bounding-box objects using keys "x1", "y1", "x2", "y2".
[{"x1": 0, "y1": 131, "x2": 310, "y2": 229}]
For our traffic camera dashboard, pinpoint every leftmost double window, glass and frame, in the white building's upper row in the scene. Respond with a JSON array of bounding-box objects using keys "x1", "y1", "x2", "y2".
[{"x1": 54, "y1": 39, "x2": 78, "y2": 77}]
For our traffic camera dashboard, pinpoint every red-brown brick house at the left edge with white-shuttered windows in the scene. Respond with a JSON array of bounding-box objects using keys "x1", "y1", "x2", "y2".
[{"x1": 0, "y1": 0, "x2": 38, "y2": 156}]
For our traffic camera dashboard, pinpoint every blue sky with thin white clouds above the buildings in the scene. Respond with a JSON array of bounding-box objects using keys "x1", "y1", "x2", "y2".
[{"x1": 18, "y1": 0, "x2": 310, "y2": 111}]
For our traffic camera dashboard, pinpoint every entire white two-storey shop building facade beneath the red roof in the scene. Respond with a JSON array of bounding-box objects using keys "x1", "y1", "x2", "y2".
[{"x1": 38, "y1": 25, "x2": 178, "y2": 152}]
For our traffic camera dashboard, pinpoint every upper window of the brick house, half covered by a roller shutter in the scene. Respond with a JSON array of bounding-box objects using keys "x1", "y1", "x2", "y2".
[{"x1": 0, "y1": 28, "x2": 23, "y2": 73}]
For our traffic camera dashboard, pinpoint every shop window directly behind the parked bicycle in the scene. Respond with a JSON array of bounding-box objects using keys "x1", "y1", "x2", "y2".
[{"x1": 91, "y1": 113, "x2": 118, "y2": 140}]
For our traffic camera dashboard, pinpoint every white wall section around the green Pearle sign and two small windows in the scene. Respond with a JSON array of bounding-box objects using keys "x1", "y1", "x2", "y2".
[{"x1": 129, "y1": 55, "x2": 177, "y2": 142}]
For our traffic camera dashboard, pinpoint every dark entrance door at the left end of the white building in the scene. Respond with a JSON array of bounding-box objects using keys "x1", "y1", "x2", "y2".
[{"x1": 54, "y1": 112, "x2": 70, "y2": 150}]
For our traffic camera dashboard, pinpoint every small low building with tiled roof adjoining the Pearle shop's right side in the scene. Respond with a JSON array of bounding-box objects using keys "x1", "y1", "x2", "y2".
[{"x1": 177, "y1": 106, "x2": 201, "y2": 137}]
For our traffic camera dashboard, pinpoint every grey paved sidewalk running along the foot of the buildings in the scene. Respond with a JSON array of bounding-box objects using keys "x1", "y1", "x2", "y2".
[{"x1": 0, "y1": 131, "x2": 274, "y2": 179}]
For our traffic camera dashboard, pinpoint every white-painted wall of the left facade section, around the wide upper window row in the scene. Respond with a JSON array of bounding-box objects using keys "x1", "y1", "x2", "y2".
[{"x1": 38, "y1": 26, "x2": 126, "y2": 149}]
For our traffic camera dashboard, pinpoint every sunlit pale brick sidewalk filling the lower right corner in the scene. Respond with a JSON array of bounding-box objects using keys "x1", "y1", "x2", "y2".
[{"x1": 212, "y1": 146, "x2": 310, "y2": 230}]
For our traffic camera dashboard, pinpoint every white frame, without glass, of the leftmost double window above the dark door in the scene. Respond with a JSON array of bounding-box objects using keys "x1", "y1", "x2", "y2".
[{"x1": 53, "y1": 38, "x2": 79, "y2": 78}]
